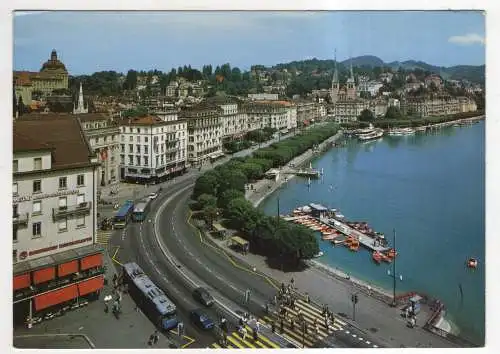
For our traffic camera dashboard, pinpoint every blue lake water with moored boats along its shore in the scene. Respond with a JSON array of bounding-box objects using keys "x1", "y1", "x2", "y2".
[{"x1": 261, "y1": 121, "x2": 485, "y2": 344}]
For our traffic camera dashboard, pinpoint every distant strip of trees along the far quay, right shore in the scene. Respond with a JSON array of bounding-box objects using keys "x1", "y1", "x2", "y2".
[{"x1": 341, "y1": 107, "x2": 485, "y2": 129}]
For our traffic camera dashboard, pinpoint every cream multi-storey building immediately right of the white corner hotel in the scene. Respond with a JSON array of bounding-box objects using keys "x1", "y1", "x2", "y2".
[{"x1": 179, "y1": 103, "x2": 224, "y2": 166}]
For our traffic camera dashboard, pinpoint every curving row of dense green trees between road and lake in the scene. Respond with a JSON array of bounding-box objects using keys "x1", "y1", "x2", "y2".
[{"x1": 191, "y1": 124, "x2": 339, "y2": 267}]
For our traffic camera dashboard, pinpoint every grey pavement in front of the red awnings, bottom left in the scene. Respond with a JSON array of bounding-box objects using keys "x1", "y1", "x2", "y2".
[{"x1": 14, "y1": 253, "x2": 178, "y2": 349}]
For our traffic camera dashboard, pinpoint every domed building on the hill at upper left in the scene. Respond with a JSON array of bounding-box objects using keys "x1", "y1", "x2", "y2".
[{"x1": 14, "y1": 49, "x2": 69, "y2": 101}]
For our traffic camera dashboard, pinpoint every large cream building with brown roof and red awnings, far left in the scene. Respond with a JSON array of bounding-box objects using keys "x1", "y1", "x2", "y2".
[{"x1": 12, "y1": 115, "x2": 104, "y2": 326}]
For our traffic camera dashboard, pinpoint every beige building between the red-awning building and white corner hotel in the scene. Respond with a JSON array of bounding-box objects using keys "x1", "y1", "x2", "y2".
[{"x1": 77, "y1": 113, "x2": 120, "y2": 188}]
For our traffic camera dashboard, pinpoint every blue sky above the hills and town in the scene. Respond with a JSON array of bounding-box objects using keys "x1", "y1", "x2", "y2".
[{"x1": 13, "y1": 11, "x2": 485, "y2": 75}]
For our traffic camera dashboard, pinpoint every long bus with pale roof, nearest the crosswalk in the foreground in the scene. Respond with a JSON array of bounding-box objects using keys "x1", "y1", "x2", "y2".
[{"x1": 123, "y1": 262, "x2": 179, "y2": 331}]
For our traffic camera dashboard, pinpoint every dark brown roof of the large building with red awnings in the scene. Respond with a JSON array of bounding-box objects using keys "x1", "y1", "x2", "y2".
[{"x1": 13, "y1": 114, "x2": 93, "y2": 169}]
